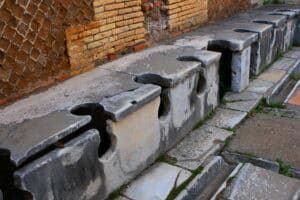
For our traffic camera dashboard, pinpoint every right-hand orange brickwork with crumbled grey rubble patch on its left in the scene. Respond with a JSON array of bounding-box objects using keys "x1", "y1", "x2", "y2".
[{"x1": 142, "y1": 0, "x2": 208, "y2": 41}]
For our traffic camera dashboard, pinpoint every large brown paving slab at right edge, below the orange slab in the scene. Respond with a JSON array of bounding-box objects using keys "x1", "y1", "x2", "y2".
[{"x1": 228, "y1": 114, "x2": 300, "y2": 168}]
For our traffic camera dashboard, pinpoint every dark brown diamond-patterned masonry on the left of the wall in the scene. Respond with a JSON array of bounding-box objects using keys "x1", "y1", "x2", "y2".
[{"x1": 0, "y1": 0, "x2": 94, "y2": 103}]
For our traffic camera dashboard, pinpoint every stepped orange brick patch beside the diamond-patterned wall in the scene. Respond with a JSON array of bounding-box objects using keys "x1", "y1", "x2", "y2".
[{"x1": 66, "y1": 0, "x2": 147, "y2": 68}]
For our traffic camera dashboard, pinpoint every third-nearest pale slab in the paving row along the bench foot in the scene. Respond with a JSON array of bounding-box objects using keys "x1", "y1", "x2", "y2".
[{"x1": 206, "y1": 108, "x2": 247, "y2": 128}]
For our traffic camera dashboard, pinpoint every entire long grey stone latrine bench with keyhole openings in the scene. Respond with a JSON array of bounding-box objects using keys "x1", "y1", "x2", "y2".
[{"x1": 0, "y1": 6, "x2": 300, "y2": 200}]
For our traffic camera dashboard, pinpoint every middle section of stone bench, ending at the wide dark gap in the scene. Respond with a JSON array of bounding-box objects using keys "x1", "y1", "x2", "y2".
[{"x1": 104, "y1": 45, "x2": 220, "y2": 149}]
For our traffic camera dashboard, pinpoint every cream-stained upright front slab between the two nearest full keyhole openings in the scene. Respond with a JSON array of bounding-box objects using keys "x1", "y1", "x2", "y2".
[{"x1": 99, "y1": 95, "x2": 162, "y2": 195}]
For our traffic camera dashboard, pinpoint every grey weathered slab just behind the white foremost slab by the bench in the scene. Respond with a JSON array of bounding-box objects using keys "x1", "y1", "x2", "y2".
[{"x1": 168, "y1": 125, "x2": 232, "y2": 170}]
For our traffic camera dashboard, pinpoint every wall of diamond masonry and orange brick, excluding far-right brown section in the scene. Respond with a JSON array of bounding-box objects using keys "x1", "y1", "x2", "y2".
[{"x1": 0, "y1": 0, "x2": 208, "y2": 105}]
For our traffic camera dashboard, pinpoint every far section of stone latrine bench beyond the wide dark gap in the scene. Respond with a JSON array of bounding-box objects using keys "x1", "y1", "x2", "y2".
[{"x1": 175, "y1": 6, "x2": 299, "y2": 92}]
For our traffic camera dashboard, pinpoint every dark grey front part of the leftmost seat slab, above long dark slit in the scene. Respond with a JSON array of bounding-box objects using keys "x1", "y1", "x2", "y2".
[{"x1": 0, "y1": 111, "x2": 91, "y2": 166}]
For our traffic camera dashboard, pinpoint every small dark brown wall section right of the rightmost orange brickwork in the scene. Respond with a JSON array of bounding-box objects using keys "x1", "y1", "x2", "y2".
[{"x1": 208, "y1": 0, "x2": 251, "y2": 21}]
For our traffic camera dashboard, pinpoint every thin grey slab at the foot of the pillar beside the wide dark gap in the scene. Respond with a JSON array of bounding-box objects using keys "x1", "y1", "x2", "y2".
[{"x1": 223, "y1": 91, "x2": 263, "y2": 101}]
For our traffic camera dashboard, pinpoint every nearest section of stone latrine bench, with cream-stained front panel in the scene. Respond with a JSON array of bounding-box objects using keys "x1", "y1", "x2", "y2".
[{"x1": 0, "y1": 68, "x2": 161, "y2": 199}]
